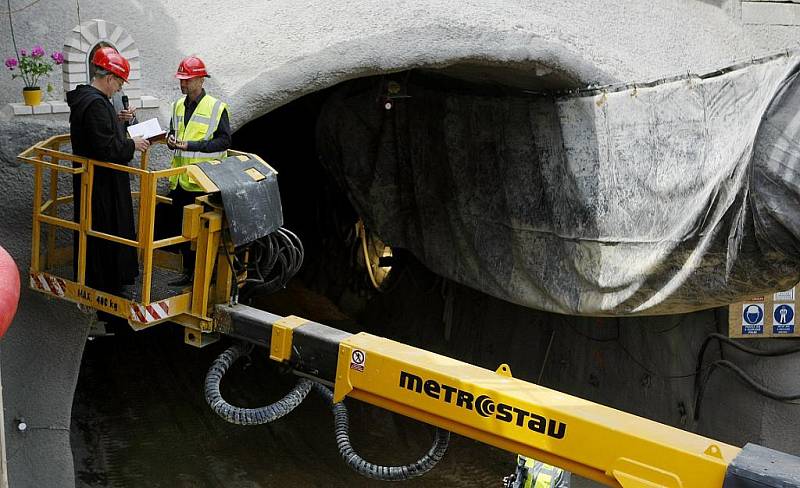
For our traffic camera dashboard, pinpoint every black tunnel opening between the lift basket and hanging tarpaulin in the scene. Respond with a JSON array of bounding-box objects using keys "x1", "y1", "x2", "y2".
[{"x1": 232, "y1": 83, "x2": 366, "y2": 320}]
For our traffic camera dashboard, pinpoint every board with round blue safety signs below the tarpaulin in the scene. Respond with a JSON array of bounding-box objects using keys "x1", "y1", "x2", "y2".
[{"x1": 728, "y1": 286, "x2": 800, "y2": 339}]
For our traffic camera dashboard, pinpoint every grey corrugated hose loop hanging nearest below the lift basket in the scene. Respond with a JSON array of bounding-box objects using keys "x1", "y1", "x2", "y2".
[{"x1": 205, "y1": 344, "x2": 312, "y2": 425}]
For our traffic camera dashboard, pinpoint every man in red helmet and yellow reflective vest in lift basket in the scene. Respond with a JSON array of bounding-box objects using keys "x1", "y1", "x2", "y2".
[{"x1": 167, "y1": 56, "x2": 231, "y2": 286}]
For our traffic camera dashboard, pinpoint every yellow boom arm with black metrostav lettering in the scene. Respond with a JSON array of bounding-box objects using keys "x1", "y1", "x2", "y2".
[{"x1": 216, "y1": 305, "x2": 800, "y2": 488}]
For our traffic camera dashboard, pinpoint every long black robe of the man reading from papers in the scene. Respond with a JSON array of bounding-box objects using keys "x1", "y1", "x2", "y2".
[{"x1": 67, "y1": 85, "x2": 139, "y2": 293}]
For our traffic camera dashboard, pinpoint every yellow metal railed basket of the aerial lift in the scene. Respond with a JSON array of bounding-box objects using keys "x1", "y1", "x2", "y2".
[{"x1": 18, "y1": 134, "x2": 250, "y2": 345}]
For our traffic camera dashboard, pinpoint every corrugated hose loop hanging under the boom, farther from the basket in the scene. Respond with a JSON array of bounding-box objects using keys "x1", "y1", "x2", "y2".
[{"x1": 313, "y1": 383, "x2": 450, "y2": 481}]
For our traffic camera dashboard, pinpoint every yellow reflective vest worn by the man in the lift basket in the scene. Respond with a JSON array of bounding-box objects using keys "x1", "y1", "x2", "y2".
[{"x1": 169, "y1": 95, "x2": 228, "y2": 191}]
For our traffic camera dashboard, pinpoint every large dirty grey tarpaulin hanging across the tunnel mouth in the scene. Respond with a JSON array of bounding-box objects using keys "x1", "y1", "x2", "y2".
[{"x1": 317, "y1": 53, "x2": 800, "y2": 315}]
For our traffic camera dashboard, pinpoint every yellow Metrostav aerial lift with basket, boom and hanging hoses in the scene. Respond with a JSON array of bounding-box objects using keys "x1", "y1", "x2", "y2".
[{"x1": 19, "y1": 136, "x2": 800, "y2": 488}]
